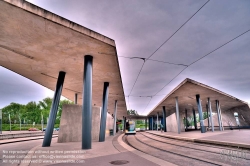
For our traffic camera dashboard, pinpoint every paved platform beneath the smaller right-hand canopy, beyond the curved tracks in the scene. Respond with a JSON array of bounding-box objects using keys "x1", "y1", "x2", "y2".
[{"x1": 146, "y1": 130, "x2": 250, "y2": 149}]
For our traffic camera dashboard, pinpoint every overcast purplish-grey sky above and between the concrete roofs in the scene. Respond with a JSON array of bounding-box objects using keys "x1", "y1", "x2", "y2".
[{"x1": 0, "y1": 0, "x2": 250, "y2": 114}]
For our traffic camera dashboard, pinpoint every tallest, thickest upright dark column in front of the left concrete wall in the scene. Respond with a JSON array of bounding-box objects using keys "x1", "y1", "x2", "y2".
[{"x1": 82, "y1": 55, "x2": 93, "y2": 149}]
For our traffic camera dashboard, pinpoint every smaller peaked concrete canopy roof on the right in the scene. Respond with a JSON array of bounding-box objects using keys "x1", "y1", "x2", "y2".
[{"x1": 148, "y1": 78, "x2": 248, "y2": 116}]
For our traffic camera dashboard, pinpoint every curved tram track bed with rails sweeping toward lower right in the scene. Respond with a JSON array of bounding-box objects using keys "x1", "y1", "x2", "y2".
[{"x1": 123, "y1": 132, "x2": 250, "y2": 166}]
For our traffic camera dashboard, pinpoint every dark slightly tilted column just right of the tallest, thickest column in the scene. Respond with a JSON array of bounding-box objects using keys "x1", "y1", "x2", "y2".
[{"x1": 99, "y1": 82, "x2": 109, "y2": 142}]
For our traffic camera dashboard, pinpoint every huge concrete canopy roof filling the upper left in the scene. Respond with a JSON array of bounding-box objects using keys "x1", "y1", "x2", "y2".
[{"x1": 0, "y1": 0, "x2": 127, "y2": 118}]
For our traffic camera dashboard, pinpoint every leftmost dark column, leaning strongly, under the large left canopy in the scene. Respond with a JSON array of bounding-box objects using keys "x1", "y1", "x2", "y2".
[{"x1": 42, "y1": 71, "x2": 66, "y2": 147}]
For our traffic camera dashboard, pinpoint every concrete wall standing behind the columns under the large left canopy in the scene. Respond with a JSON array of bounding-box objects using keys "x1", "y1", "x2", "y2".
[{"x1": 58, "y1": 104, "x2": 113, "y2": 143}]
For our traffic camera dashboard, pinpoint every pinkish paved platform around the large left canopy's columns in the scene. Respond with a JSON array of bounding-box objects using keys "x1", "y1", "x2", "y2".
[{"x1": 8, "y1": 133, "x2": 175, "y2": 166}]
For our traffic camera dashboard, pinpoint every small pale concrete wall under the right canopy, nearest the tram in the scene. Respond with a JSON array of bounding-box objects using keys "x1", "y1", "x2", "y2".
[{"x1": 166, "y1": 113, "x2": 185, "y2": 133}]
